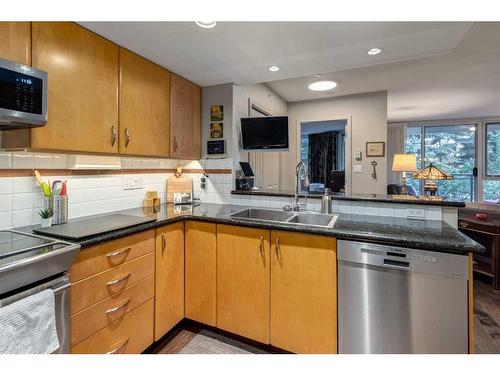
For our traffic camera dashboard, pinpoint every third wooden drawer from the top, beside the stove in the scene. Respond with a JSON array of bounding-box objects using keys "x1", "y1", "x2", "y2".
[{"x1": 71, "y1": 275, "x2": 154, "y2": 346}]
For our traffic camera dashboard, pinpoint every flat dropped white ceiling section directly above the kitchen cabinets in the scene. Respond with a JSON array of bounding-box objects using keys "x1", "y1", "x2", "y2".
[{"x1": 80, "y1": 22, "x2": 471, "y2": 86}]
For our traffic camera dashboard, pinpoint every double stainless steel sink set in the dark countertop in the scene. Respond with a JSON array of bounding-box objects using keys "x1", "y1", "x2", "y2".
[{"x1": 229, "y1": 208, "x2": 338, "y2": 228}]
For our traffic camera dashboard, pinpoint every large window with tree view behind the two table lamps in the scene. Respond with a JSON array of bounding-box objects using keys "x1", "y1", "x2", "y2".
[{"x1": 406, "y1": 124, "x2": 476, "y2": 202}]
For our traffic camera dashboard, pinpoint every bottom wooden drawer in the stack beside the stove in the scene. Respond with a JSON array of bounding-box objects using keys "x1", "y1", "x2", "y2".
[{"x1": 71, "y1": 299, "x2": 154, "y2": 354}]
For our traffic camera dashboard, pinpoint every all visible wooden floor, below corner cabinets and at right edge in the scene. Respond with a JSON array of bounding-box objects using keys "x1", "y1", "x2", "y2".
[{"x1": 149, "y1": 279, "x2": 500, "y2": 354}]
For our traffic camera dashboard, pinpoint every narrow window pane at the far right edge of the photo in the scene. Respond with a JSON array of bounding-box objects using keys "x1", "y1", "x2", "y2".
[{"x1": 483, "y1": 123, "x2": 500, "y2": 202}]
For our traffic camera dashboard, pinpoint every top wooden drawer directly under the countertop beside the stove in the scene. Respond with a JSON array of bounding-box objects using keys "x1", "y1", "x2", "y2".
[{"x1": 70, "y1": 230, "x2": 155, "y2": 283}]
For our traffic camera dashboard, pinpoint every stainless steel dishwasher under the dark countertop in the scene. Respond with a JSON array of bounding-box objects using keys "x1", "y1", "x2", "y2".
[{"x1": 337, "y1": 240, "x2": 468, "y2": 353}]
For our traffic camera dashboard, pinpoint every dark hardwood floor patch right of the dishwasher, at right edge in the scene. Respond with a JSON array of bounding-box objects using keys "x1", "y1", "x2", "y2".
[{"x1": 474, "y1": 278, "x2": 500, "y2": 354}]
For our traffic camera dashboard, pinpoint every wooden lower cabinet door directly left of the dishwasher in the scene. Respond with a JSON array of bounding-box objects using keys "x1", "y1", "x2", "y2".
[{"x1": 271, "y1": 231, "x2": 337, "y2": 354}]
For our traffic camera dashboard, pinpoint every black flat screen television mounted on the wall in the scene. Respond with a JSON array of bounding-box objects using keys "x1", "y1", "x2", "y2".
[{"x1": 241, "y1": 116, "x2": 288, "y2": 151}]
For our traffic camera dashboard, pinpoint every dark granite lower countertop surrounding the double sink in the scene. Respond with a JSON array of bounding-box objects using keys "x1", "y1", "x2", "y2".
[{"x1": 17, "y1": 203, "x2": 484, "y2": 255}]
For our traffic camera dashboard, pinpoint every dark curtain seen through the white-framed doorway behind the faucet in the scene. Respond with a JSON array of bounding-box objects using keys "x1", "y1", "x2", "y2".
[{"x1": 308, "y1": 131, "x2": 337, "y2": 187}]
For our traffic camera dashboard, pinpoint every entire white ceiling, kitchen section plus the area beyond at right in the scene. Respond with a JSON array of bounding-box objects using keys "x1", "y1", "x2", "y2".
[{"x1": 81, "y1": 22, "x2": 500, "y2": 121}]
